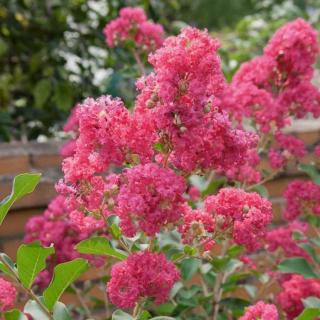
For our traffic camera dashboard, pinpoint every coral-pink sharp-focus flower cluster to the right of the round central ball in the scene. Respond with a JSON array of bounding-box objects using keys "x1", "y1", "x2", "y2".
[{"x1": 205, "y1": 188, "x2": 272, "y2": 251}]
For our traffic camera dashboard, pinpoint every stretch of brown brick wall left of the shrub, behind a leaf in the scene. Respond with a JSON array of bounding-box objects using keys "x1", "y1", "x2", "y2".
[{"x1": 0, "y1": 141, "x2": 62, "y2": 258}]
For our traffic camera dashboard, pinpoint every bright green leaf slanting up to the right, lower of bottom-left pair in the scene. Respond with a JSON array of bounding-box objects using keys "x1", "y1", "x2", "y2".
[{"x1": 43, "y1": 258, "x2": 89, "y2": 310}]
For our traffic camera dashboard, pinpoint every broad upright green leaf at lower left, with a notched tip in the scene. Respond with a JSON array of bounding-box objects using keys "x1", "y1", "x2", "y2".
[{"x1": 17, "y1": 242, "x2": 54, "y2": 288}]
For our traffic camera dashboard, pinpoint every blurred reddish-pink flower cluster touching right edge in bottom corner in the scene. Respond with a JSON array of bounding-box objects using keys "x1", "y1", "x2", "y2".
[{"x1": 277, "y1": 275, "x2": 320, "y2": 320}]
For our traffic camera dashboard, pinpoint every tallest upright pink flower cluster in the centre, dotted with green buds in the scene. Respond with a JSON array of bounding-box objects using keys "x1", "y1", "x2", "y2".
[{"x1": 136, "y1": 27, "x2": 257, "y2": 172}]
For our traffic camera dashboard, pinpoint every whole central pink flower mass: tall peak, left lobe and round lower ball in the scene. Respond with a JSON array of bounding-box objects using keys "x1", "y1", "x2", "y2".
[{"x1": 57, "y1": 28, "x2": 257, "y2": 236}]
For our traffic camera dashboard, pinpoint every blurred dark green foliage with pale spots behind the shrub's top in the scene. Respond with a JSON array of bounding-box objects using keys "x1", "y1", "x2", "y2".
[{"x1": 0, "y1": 0, "x2": 320, "y2": 142}]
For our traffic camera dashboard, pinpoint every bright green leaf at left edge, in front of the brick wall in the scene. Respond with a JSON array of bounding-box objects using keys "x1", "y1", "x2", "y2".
[{"x1": 0, "y1": 173, "x2": 41, "y2": 225}]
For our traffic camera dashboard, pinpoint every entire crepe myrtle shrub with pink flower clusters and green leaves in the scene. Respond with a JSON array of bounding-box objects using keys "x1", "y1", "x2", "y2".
[{"x1": 0, "y1": 8, "x2": 320, "y2": 320}]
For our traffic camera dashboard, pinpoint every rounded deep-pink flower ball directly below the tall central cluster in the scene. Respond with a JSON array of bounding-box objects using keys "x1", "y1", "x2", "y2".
[{"x1": 115, "y1": 163, "x2": 185, "y2": 236}]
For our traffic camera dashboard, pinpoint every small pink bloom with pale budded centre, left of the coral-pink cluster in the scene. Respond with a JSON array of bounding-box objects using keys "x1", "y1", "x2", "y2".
[{"x1": 179, "y1": 206, "x2": 215, "y2": 251}]
